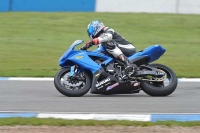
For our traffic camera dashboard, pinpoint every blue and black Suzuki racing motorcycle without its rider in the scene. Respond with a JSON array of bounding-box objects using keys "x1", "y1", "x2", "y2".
[{"x1": 54, "y1": 40, "x2": 177, "y2": 97}]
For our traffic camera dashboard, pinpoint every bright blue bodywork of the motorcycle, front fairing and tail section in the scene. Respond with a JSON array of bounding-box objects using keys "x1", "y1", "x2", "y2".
[{"x1": 59, "y1": 40, "x2": 165, "y2": 74}]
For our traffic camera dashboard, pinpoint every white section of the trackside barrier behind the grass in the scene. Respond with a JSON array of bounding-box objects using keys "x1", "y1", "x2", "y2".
[{"x1": 96, "y1": 0, "x2": 200, "y2": 14}]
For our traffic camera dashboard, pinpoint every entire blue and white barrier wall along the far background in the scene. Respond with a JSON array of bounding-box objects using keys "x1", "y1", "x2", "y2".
[{"x1": 0, "y1": 0, "x2": 200, "y2": 14}]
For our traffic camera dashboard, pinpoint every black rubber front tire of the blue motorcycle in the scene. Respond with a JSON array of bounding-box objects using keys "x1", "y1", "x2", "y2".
[{"x1": 54, "y1": 68, "x2": 92, "y2": 97}]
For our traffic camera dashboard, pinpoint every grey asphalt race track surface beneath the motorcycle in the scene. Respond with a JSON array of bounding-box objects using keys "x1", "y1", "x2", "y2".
[{"x1": 0, "y1": 81, "x2": 200, "y2": 114}]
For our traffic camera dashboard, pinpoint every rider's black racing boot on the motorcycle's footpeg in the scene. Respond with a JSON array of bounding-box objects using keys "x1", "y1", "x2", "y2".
[{"x1": 119, "y1": 54, "x2": 136, "y2": 74}]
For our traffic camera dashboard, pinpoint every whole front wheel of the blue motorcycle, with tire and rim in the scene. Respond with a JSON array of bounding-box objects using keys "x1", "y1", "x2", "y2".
[{"x1": 54, "y1": 68, "x2": 92, "y2": 97}]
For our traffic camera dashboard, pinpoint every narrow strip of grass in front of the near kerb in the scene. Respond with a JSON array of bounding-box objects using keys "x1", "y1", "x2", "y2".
[{"x1": 0, "y1": 118, "x2": 200, "y2": 127}]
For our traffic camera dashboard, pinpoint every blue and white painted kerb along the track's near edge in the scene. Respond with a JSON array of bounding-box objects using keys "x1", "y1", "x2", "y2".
[{"x1": 0, "y1": 112, "x2": 200, "y2": 122}]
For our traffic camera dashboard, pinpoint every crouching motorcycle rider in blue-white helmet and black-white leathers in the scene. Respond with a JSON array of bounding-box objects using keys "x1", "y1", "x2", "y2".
[{"x1": 84, "y1": 20, "x2": 136, "y2": 73}]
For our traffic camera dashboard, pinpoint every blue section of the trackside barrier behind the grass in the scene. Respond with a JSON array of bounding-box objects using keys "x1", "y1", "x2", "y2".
[{"x1": 0, "y1": 0, "x2": 95, "y2": 12}]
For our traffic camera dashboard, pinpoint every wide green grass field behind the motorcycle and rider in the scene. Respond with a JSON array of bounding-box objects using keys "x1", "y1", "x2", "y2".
[{"x1": 0, "y1": 12, "x2": 200, "y2": 77}]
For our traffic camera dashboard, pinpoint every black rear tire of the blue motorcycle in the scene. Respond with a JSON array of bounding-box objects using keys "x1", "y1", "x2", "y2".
[{"x1": 141, "y1": 64, "x2": 178, "y2": 96}]
